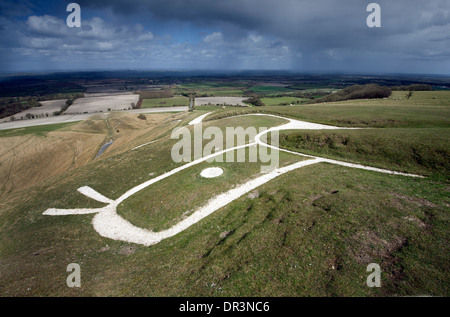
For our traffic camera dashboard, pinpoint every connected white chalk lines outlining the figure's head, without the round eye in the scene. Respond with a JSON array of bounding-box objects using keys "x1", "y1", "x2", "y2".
[{"x1": 43, "y1": 114, "x2": 421, "y2": 246}]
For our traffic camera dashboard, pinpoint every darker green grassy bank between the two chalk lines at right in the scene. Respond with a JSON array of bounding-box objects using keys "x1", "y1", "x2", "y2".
[{"x1": 280, "y1": 128, "x2": 450, "y2": 179}]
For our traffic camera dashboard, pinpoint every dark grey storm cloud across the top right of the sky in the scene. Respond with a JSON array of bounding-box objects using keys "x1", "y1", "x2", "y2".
[{"x1": 75, "y1": 0, "x2": 450, "y2": 61}]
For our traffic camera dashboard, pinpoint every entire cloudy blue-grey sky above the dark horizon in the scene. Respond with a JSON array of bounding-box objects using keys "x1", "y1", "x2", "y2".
[{"x1": 0, "y1": 0, "x2": 450, "y2": 75}]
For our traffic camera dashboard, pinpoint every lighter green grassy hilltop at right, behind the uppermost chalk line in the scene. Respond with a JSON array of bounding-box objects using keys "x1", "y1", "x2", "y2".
[{"x1": 207, "y1": 91, "x2": 450, "y2": 128}]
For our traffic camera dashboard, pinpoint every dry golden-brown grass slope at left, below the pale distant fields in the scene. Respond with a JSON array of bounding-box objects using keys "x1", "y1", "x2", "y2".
[{"x1": 0, "y1": 113, "x2": 186, "y2": 198}]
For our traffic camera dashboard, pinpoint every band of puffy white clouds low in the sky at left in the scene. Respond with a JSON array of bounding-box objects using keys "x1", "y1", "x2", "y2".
[{"x1": 0, "y1": 15, "x2": 298, "y2": 69}]
